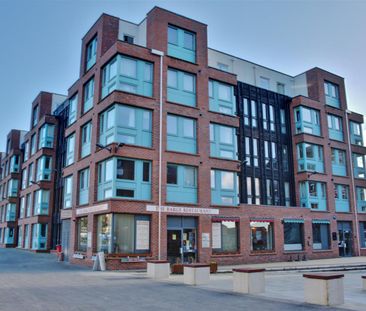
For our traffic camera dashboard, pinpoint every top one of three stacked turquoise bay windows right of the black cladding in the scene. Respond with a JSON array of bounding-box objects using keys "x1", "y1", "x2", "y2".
[{"x1": 294, "y1": 106, "x2": 321, "y2": 136}]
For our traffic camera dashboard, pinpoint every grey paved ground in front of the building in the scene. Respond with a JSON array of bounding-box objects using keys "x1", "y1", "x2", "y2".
[{"x1": 0, "y1": 249, "x2": 366, "y2": 311}]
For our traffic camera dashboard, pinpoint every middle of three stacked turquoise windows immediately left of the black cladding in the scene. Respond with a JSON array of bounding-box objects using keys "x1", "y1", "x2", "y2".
[{"x1": 210, "y1": 123, "x2": 238, "y2": 160}]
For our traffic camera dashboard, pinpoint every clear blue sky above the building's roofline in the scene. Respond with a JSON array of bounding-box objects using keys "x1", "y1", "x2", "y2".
[{"x1": 0, "y1": 0, "x2": 366, "y2": 151}]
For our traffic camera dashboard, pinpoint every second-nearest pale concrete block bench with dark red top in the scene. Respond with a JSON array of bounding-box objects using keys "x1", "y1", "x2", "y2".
[{"x1": 233, "y1": 268, "x2": 265, "y2": 294}]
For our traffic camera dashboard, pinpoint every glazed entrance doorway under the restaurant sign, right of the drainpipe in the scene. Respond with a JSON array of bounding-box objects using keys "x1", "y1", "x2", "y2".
[{"x1": 167, "y1": 216, "x2": 198, "y2": 263}]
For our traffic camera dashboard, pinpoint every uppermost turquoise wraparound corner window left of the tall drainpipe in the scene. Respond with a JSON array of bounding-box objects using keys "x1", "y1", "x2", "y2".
[{"x1": 102, "y1": 55, "x2": 153, "y2": 98}]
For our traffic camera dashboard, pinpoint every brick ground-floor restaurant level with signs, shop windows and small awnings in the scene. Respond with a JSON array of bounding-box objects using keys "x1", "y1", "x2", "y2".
[{"x1": 57, "y1": 203, "x2": 366, "y2": 269}]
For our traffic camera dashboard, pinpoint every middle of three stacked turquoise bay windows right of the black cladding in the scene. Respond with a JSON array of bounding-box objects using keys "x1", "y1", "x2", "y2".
[{"x1": 296, "y1": 143, "x2": 324, "y2": 173}]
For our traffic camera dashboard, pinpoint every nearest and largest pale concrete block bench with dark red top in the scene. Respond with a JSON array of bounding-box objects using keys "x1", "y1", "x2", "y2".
[{"x1": 303, "y1": 273, "x2": 344, "y2": 306}]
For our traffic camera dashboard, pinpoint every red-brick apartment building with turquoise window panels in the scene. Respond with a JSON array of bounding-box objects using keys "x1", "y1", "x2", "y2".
[{"x1": 1, "y1": 7, "x2": 366, "y2": 269}]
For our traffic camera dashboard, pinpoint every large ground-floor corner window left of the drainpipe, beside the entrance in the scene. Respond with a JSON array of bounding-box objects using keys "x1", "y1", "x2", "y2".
[{"x1": 97, "y1": 214, "x2": 150, "y2": 254}]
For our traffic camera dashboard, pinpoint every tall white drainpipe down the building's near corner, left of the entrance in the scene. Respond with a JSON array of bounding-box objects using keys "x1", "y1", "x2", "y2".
[{"x1": 151, "y1": 49, "x2": 164, "y2": 260}]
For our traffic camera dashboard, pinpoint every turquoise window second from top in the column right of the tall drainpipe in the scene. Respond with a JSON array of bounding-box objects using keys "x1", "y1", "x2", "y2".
[{"x1": 167, "y1": 68, "x2": 196, "y2": 107}]
